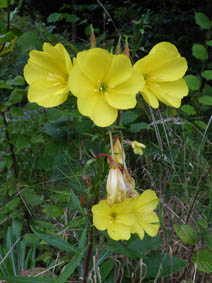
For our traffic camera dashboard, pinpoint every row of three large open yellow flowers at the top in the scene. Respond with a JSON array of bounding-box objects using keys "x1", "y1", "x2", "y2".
[{"x1": 24, "y1": 42, "x2": 188, "y2": 127}]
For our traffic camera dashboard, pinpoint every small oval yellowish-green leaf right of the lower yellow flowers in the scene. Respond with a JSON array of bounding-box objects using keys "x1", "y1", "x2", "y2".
[{"x1": 174, "y1": 224, "x2": 198, "y2": 245}]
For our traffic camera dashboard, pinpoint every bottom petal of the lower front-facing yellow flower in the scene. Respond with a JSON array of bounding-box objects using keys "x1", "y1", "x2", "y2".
[{"x1": 107, "y1": 223, "x2": 130, "y2": 241}]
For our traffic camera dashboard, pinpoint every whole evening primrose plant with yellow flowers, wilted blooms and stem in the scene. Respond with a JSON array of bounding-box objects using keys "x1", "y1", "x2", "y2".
[{"x1": 24, "y1": 31, "x2": 188, "y2": 282}]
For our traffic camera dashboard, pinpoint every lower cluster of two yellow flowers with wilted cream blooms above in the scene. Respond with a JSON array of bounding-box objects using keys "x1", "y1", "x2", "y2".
[{"x1": 92, "y1": 139, "x2": 159, "y2": 241}]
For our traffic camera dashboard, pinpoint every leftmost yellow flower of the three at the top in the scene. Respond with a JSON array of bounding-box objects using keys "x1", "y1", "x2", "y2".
[{"x1": 24, "y1": 43, "x2": 72, "y2": 107}]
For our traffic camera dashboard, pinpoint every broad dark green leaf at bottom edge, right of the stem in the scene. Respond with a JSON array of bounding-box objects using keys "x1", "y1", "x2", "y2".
[{"x1": 144, "y1": 253, "x2": 187, "y2": 279}]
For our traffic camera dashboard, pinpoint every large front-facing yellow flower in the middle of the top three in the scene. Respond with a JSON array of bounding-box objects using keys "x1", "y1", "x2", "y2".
[{"x1": 69, "y1": 48, "x2": 144, "y2": 127}]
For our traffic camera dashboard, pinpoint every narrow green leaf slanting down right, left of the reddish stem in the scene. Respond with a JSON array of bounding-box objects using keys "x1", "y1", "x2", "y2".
[{"x1": 32, "y1": 231, "x2": 76, "y2": 254}]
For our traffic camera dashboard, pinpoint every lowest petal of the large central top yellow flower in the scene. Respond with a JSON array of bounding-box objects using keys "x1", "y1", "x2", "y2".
[{"x1": 90, "y1": 95, "x2": 118, "y2": 127}]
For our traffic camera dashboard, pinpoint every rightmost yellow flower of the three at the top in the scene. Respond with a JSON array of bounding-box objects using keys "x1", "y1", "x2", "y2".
[{"x1": 134, "y1": 42, "x2": 188, "y2": 108}]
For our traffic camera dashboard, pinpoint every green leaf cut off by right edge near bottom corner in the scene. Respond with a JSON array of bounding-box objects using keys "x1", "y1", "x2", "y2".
[{"x1": 192, "y1": 249, "x2": 212, "y2": 273}]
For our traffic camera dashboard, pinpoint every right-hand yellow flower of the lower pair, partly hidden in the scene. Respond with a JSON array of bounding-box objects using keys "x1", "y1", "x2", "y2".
[{"x1": 131, "y1": 190, "x2": 160, "y2": 240}]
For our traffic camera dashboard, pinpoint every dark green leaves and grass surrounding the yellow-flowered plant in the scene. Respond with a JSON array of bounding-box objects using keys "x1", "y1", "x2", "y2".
[{"x1": 0, "y1": 0, "x2": 212, "y2": 283}]
